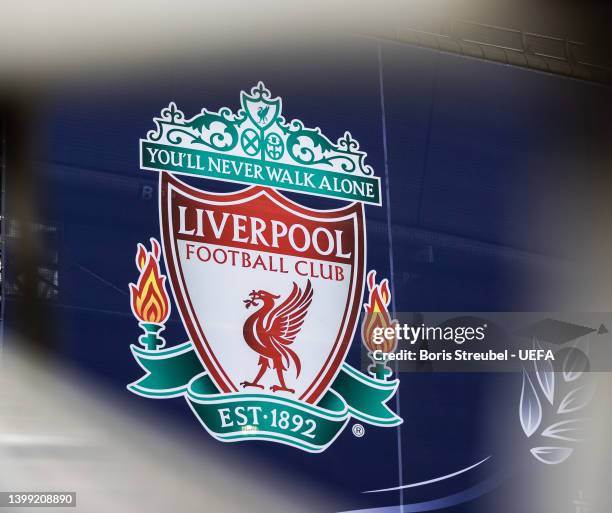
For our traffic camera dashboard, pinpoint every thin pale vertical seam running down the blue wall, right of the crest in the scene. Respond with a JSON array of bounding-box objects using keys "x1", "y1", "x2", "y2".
[{"x1": 378, "y1": 41, "x2": 404, "y2": 509}]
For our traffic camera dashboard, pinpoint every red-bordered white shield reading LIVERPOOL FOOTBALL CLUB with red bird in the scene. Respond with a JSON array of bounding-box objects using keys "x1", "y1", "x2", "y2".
[{"x1": 160, "y1": 173, "x2": 366, "y2": 403}]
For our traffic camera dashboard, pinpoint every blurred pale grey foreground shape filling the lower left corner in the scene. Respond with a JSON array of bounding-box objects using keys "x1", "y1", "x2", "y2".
[{"x1": 0, "y1": 344, "x2": 333, "y2": 513}]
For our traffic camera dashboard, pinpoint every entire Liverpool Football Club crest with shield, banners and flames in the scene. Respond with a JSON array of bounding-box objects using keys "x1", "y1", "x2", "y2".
[{"x1": 128, "y1": 83, "x2": 401, "y2": 452}]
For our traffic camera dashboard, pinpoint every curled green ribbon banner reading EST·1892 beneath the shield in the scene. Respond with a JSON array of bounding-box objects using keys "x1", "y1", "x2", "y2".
[{"x1": 128, "y1": 342, "x2": 402, "y2": 452}]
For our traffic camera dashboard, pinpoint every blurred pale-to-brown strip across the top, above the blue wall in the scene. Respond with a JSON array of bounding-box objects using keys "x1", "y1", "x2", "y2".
[{"x1": 0, "y1": 0, "x2": 612, "y2": 90}]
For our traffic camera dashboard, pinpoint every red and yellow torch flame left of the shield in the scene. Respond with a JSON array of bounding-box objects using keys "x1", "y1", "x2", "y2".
[{"x1": 130, "y1": 238, "x2": 170, "y2": 324}]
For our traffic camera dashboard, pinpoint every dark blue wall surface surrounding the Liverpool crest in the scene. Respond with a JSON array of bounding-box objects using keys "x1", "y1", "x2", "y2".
[{"x1": 7, "y1": 39, "x2": 612, "y2": 511}]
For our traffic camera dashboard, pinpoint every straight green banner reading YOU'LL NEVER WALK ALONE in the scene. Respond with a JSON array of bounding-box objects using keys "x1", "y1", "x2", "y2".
[{"x1": 140, "y1": 140, "x2": 381, "y2": 205}]
